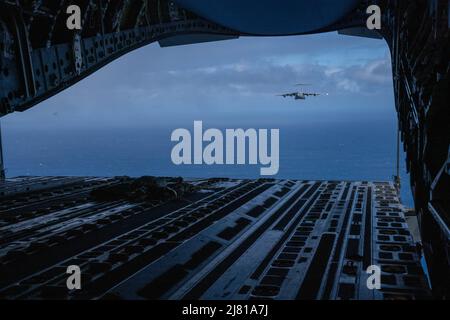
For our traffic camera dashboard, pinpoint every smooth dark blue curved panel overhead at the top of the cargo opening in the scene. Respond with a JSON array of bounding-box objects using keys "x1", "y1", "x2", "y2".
[{"x1": 174, "y1": 0, "x2": 360, "y2": 35}]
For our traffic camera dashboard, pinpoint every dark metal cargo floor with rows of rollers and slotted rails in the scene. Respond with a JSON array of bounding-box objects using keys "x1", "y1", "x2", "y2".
[{"x1": 0, "y1": 177, "x2": 429, "y2": 300}]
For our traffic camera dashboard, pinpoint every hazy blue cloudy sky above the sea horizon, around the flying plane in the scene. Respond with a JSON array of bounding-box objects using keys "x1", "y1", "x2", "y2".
[{"x1": 2, "y1": 33, "x2": 394, "y2": 130}]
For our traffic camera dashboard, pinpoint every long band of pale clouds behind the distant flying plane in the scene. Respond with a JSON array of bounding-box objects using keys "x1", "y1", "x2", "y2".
[{"x1": 135, "y1": 52, "x2": 392, "y2": 98}]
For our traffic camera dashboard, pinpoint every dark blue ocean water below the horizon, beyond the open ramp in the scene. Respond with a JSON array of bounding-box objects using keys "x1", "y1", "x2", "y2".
[{"x1": 3, "y1": 121, "x2": 412, "y2": 206}]
